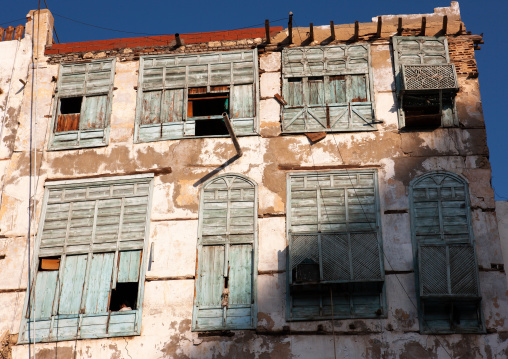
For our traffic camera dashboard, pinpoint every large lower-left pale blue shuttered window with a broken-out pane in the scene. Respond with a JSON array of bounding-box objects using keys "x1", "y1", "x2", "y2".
[{"x1": 19, "y1": 175, "x2": 153, "y2": 343}]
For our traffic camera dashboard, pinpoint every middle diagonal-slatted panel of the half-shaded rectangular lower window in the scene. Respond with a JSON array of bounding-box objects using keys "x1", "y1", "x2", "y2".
[{"x1": 321, "y1": 234, "x2": 351, "y2": 281}]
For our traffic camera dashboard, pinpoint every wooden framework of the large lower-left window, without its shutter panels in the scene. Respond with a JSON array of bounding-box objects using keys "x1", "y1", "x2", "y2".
[{"x1": 18, "y1": 174, "x2": 154, "y2": 344}]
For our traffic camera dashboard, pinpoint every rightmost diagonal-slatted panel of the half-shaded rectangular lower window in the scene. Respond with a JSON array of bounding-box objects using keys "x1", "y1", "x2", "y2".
[{"x1": 351, "y1": 233, "x2": 382, "y2": 281}]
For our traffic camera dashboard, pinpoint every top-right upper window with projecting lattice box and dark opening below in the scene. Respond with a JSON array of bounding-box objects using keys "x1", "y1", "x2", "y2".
[{"x1": 393, "y1": 36, "x2": 458, "y2": 129}]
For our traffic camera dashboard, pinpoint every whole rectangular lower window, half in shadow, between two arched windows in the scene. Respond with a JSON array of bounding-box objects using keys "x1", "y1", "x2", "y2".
[{"x1": 287, "y1": 170, "x2": 386, "y2": 320}]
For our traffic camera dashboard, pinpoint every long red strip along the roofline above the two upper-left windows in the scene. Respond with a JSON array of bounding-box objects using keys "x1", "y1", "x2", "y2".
[{"x1": 45, "y1": 26, "x2": 282, "y2": 55}]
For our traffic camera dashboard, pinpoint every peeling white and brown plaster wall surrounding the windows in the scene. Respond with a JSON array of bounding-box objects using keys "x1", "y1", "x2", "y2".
[{"x1": 0, "y1": 3, "x2": 508, "y2": 359}]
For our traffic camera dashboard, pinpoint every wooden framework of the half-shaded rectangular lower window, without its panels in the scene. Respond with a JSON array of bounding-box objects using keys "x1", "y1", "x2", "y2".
[{"x1": 286, "y1": 170, "x2": 387, "y2": 321}]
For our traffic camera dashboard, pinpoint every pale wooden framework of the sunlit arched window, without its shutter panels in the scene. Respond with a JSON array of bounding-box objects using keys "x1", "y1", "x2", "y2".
[{"x1": 192, "y1": 173, "x2": 258, "y2": 331}]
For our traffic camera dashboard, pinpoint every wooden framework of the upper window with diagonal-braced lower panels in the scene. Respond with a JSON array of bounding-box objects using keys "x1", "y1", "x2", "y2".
[{"x1": 281, "y1": 43, "x2": 377, "y2": 134}]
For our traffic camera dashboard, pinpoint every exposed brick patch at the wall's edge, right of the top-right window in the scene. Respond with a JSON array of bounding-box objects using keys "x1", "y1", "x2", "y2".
[{"x1": 448, "y1": 35, "x2": 478, "y2": 77}]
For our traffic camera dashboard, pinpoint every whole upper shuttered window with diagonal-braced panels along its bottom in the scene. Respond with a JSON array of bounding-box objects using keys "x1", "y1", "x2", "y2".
[{"x1": 282, "y1": 44, "x2": 377, "y2": 133}]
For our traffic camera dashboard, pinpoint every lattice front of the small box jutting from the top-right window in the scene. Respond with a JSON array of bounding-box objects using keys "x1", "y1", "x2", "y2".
[{"x1": 402, "y1": 64, "x2": 458, "y2": 91}]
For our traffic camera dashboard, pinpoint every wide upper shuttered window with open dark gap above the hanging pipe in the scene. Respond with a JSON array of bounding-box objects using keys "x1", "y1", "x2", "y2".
[{"x1": 134, "y1": 50, "x2": 259, "y2": 142}]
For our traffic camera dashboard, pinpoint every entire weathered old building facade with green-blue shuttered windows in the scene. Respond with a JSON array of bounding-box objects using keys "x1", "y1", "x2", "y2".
[{"x1": 0, "y1": 2, "x2": 508, "y2": 358}]
